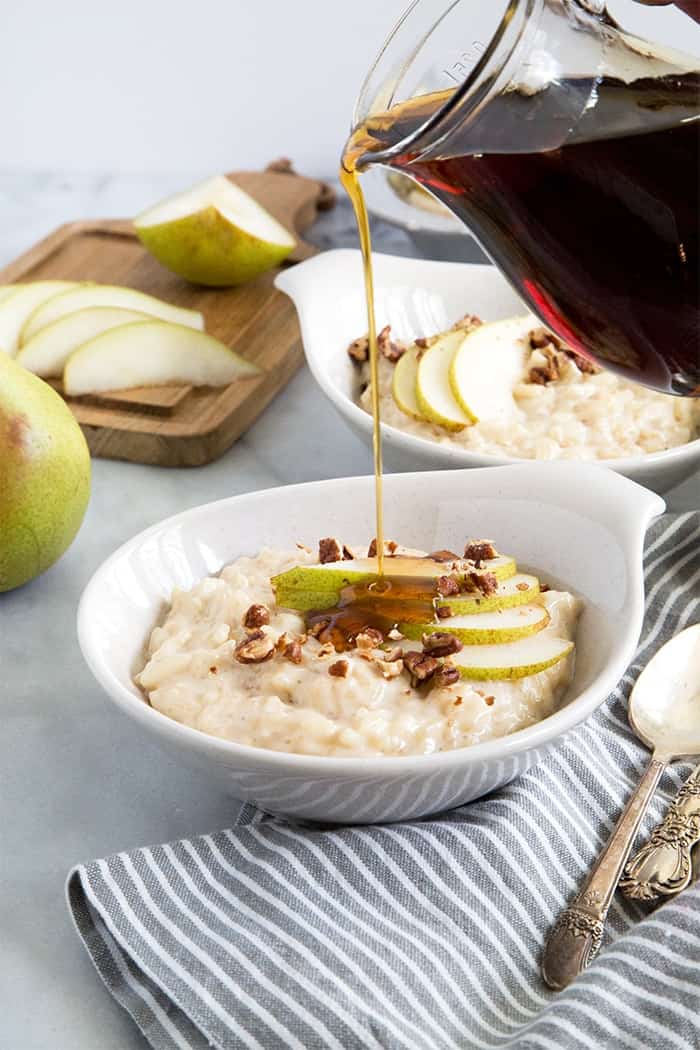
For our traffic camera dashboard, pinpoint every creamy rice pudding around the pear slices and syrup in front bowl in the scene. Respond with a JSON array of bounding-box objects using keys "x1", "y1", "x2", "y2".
[{"x1": 136, "y1": 541, "x2": 580, "y2": 756}]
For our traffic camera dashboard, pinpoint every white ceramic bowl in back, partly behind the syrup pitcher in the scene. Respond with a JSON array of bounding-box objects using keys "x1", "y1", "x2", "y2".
[{"x1": 276, "y1": 250, "x2": 700, "y2": 492}]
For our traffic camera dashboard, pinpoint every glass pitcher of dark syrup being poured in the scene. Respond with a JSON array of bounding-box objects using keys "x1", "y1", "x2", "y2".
[{"x1": 346, "y1": 0, "x2": 700, "y2": 395}]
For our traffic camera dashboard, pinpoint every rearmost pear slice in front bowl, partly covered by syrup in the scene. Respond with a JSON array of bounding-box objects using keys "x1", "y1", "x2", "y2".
[{"x1": 271, "y1": 554, "x2": 516, "y2": 611}]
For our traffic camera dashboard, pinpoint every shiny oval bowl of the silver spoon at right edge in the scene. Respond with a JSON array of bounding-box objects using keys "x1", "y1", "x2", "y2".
[{"x1": 630, "y1": 624, "x2": 700, "y2": 762}]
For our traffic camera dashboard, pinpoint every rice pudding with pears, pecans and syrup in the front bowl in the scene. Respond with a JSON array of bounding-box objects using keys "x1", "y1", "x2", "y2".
[{"x1": 135, "y1": 539, "x2": 581, "y2": 758}]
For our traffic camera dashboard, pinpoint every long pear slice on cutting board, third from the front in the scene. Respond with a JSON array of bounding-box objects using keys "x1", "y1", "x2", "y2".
[{"x1": 21, "y1": 285, "x2": 205, "y2": 344}]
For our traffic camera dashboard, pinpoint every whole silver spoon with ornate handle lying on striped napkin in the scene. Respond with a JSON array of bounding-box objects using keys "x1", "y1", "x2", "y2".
[{"x1": 542, "y1": 624, "x2": 700, "y2": 990}]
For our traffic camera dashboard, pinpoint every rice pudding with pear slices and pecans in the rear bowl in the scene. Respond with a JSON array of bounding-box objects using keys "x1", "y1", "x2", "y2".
[{"x1": 348, "y1": 314, "x2": 700, "y2": 461}]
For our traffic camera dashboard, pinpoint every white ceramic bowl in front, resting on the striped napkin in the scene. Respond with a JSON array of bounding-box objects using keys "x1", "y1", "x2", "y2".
[{"x1": 78, "y1": 463, "x2": 664, "y2": 823}]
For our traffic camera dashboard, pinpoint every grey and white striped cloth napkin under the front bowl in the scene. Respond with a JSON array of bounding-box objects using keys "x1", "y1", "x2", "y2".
[{"x1": 67, "y1": 513, "x2": 700, "y2": 1050}]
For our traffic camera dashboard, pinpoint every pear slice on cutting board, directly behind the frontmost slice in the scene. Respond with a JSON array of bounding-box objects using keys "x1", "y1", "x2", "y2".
[{"x1": 17, "y1": 307, "x2": 153, "y2": 377}]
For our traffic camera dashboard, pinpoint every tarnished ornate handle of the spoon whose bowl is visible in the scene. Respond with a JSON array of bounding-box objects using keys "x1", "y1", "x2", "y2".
[{"x1": 542, "y1": 757, "x2": 665, "y2": 991}]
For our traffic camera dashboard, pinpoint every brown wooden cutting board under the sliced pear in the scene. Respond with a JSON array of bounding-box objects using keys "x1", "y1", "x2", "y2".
[{"x1": 0, "y1": 166, "x2": 334, "y2": 466}]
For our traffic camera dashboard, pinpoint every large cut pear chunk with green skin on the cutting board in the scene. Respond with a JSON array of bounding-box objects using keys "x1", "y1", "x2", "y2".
[{"x1": 134, "y1": 175, "x2": 296, "y2": 287}]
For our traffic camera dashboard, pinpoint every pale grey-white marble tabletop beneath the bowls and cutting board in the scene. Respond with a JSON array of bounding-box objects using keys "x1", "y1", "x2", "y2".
[{"x1": 0, "y1": 172, "x2": 700, "y2": 1050}]
